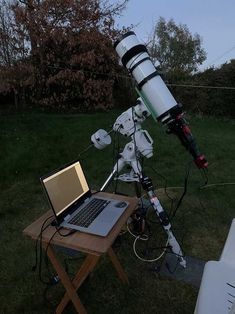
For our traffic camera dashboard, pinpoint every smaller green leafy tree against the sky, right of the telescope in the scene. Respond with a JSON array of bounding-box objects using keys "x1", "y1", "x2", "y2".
[{"x1": 148, "y1": 17, "x2": 206, "y2": 77}]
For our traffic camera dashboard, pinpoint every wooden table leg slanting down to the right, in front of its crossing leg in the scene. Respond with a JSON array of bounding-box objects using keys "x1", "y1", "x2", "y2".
[{"x1": 47, "y1": 246, "x2": 87, "y2": 314}]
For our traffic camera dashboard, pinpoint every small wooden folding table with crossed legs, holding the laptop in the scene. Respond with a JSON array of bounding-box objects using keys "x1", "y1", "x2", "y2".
[{"x1": 23, "y1": 192, "x2": 138, "y2": 314}]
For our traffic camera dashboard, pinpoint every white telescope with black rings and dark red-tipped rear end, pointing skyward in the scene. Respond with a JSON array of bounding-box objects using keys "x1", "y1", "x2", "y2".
[{"x1": 114, "y1": 31, "x2": 208, "y2": 169}]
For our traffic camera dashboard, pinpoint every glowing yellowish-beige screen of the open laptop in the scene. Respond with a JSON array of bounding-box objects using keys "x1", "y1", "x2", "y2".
[{"x1": 42, "y1": 161, "x2": 89, "y2": 216}]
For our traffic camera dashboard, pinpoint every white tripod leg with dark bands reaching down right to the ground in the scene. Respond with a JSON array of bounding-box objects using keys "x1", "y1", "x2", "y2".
[{"x1": 142, "y1": 177, "x2": 186, "y2": 268}]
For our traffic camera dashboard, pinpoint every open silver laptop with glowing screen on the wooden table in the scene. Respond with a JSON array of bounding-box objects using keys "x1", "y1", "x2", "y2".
[{"x1": 40, "y1": 161, "x2": 129, "y2": 236}]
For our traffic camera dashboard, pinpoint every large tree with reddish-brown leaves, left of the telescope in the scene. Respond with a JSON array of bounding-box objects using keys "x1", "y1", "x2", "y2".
[{"x1": 0, "y1": 0, "x2": 127, "y2": 111}]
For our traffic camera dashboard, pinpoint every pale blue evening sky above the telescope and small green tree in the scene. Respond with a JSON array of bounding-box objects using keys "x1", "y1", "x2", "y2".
[{"x1": 113, "y1": 0, "x2": 235, "y2": 70}]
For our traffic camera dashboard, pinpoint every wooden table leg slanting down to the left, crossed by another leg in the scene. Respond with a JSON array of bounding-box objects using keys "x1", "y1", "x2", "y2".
[{"x1": 56, "y1": 254, "x2": 100, "y2": 314}]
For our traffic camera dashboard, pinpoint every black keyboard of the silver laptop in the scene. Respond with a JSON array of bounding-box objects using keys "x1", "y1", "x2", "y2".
[{"x1": 69, "y1": 198, "x2": 110, "y2": 228}]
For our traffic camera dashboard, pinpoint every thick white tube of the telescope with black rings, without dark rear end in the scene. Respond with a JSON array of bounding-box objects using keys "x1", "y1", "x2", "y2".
[{"x1": 114, "y1": 32, "x2": 177, "y2": 120}]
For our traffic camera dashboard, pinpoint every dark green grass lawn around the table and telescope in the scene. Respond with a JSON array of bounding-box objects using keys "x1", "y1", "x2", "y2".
[{"x1": 0, "y1": 106, "x2": 235, "y2": 314}]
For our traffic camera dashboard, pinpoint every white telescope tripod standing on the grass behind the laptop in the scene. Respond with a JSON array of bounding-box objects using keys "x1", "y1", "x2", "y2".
[{"x1": 100, "y1": 141, "x2": 186, "y2": 268}]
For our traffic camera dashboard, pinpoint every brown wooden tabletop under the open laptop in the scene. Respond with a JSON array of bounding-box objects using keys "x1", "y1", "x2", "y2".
[{"x1": 23, "y1": 192, "x2": 138, "y2": 255}]
